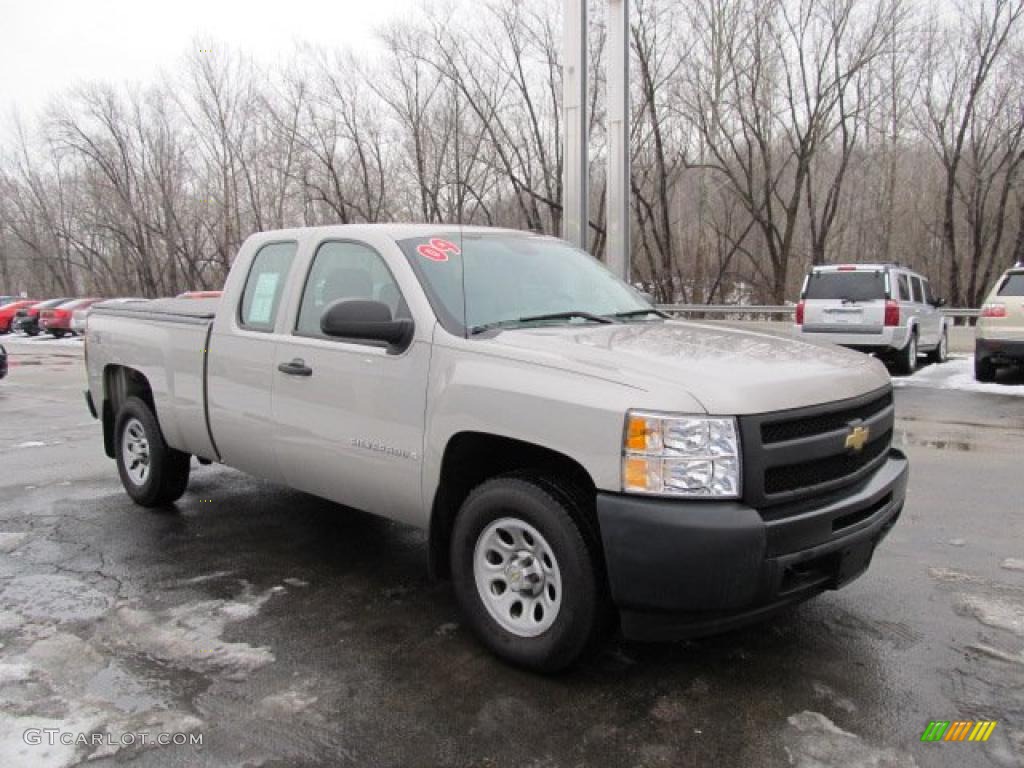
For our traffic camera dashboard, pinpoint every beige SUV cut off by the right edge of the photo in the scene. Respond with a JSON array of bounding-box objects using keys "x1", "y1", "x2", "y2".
[{"x1": 974, "y1": 264, "x2": 1024, "y2": 382}]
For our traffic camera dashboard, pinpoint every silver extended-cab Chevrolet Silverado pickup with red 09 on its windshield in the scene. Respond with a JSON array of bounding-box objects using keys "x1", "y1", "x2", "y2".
[{"x1": 86, "y1": 225, "x2": 907, "y2": 671}]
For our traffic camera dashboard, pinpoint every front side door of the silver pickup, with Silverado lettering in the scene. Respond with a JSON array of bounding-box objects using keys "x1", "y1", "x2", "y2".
[{"x1": 272, "y1": 241, "x2": 430, "y2": 522}]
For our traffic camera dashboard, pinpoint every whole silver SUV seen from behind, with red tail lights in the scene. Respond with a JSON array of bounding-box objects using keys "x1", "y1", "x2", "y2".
[{"x1": 796, "y1": 264, "x2": 949, "y2": 374}]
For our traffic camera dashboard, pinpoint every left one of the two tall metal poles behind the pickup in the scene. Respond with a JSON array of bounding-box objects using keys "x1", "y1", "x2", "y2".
[{"x1": 562, "y1": 0, "x2": 590, "y2": 250}]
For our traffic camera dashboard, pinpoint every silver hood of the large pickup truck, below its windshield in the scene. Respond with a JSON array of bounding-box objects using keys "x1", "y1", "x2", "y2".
[{"x1": 484, "y1": 321, "x2": 890, "y2": 415}]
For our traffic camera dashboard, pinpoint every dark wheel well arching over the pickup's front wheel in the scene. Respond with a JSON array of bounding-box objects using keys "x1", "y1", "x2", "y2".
[{"x1": 429, "y1": 432, "x2": 598, "y2": 579}]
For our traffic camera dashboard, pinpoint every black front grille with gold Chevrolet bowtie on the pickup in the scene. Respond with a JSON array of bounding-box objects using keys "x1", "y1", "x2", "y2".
[{"x1": 739, "y1": 387, "x2": 895, "y2": 509}]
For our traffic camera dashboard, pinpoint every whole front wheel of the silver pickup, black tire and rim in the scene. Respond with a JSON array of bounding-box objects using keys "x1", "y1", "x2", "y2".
[{"x1": 452, "y1": 476, "x2": 605, "y2": 672}]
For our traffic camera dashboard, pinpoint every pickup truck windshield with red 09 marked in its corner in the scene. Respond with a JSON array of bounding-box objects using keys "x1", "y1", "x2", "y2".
[{"x1": 398, "y1": 232, "x2": 651, "y2": 335}]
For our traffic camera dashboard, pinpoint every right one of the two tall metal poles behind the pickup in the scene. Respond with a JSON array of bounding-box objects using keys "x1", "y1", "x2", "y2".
[{"x1": 606, "y1": 0, "x2": 632, "y2": 283}]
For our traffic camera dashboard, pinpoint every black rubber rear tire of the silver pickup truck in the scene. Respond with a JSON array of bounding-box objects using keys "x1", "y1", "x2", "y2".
[{"x1": 114, "y1": 397, "x2": 191, "y2": 507}]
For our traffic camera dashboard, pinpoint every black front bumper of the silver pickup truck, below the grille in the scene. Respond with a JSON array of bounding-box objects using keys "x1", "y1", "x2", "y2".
[{"x1": 597, "y1": 449, "x2": 909, "y2": 640}]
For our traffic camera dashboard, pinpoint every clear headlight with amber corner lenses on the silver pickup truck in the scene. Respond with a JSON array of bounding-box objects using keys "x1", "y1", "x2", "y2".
[{"x1": 623, "y1": 411, "x2": 740, "y2": 499}]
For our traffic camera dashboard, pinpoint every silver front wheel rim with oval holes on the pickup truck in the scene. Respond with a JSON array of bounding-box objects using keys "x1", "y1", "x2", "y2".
[{"x1": 473, "y1": 517, "x2": 562, "y2": 637}]
